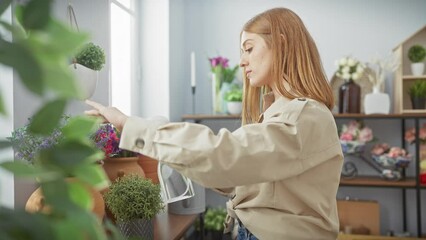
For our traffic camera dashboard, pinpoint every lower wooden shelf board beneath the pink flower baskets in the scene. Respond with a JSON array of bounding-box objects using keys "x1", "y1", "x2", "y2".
[{"x1": 340, "y1": 176, "x2": 416, "y2": 188}]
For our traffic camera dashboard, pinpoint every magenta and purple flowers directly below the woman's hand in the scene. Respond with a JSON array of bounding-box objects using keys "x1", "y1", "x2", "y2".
[{"x1": 91, "y1": 123, "x2": 137, "y2": 158}]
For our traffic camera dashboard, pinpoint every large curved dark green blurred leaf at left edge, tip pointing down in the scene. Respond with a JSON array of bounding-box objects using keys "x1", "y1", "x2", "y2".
[{"x1": 0, "y1": 38, "x2": 44, "y2": 95}]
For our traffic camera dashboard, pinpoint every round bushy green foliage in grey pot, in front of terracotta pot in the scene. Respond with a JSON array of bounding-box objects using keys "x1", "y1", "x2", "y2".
[{"x1": 104, "y1": 174, "x2": 164, "y2": 222}]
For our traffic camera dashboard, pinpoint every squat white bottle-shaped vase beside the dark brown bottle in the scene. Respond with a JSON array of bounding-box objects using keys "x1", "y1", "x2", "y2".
[{"x1": 364, "y1": 86, "x2": 390, "y2": 114}]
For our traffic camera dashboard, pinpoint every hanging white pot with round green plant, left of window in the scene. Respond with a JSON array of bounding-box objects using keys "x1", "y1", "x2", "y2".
[{"x1": 71, "y1": 42, "x2": 105, "y2": 99}]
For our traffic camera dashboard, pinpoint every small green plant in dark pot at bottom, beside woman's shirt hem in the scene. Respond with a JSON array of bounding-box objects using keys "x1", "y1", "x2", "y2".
[{"x1": 204, "y1": 207, "x2": 226, "y2": 240}]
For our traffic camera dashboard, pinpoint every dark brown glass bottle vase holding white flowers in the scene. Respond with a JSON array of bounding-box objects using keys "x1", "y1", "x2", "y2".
[{"x1": 339, "y1": 79, "x2": 361, "y2": 113}]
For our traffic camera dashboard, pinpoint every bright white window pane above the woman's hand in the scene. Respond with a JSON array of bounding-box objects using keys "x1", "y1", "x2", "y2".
[{"x1": 110, "y1": 0, "x2": 136, "y2": 115}]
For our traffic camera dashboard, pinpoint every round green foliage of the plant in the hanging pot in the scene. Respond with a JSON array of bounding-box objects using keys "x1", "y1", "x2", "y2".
[{"x1": 76, "y1": 42, "x2": 105, "y2": 71}]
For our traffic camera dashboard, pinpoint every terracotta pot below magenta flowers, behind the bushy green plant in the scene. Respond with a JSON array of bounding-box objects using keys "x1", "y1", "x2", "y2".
[{"x1": 103, "y1": 157, "x2": 145, "y2": 182}]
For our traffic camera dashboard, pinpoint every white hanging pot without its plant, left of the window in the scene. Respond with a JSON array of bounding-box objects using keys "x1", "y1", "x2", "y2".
[{"x1": 69, "y1": 63, "x2": 98, "y2": 99}]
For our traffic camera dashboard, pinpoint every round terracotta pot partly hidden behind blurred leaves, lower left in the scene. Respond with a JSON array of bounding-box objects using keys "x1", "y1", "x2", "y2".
[{"x1": 25, "y1": 178, "x2": 105, "y2": 221}]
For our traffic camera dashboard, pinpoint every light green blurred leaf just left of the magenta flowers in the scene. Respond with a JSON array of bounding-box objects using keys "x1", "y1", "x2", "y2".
[{"x1": 62, "y1": 116, "x2": 100, "y2": 139}]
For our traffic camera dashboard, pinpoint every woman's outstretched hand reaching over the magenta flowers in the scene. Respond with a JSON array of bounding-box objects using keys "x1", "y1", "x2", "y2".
[{"x1": 84, "y1": 100, "x2": 128, "y2": 131}]
